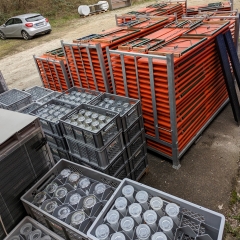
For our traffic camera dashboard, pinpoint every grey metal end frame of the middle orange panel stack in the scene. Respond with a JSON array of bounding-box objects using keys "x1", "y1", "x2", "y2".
[{"x1": 61, "y1": 40, "x2": 111, "y2": 93}]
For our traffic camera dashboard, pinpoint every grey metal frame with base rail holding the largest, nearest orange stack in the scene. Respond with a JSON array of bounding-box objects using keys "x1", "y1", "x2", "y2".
[{"x1": 107, "y1": 48, "x2": 229, "y2": 169}]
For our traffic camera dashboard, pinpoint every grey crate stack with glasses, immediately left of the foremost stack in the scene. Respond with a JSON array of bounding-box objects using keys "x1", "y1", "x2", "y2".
[{"x1": 29, "y1": 99, "x2": 75, "y2": 163}]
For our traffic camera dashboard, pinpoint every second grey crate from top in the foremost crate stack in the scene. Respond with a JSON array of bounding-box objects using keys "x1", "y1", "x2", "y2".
[{"x1": 65, "y1": 132, "x2": 124, "y2": 167}]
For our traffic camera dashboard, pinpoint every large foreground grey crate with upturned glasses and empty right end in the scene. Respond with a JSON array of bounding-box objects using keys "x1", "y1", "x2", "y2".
[{"x1": 87, "y1": 179, "x2": 225, "y2": 240}]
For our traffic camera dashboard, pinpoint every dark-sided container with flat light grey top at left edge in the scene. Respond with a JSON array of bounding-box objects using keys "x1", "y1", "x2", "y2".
[{"x1": 0, "y1": 109, "x2": 52, "y2": 239}]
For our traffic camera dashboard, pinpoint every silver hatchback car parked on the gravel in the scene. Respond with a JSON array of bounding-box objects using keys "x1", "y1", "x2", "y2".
[{"x1": 0, "y1": 13, "x2": 52, "y2": 40}]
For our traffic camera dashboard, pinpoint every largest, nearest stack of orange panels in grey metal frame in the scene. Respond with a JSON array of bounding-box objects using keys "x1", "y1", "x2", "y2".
[{"x1": 108, "y1": 16, "x2": 239, "y2": 168}]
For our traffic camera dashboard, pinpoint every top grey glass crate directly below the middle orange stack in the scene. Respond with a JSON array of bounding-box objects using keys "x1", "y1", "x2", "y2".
[{"x1": 57, "y1": 87, "x2": 102, "y2": 106}]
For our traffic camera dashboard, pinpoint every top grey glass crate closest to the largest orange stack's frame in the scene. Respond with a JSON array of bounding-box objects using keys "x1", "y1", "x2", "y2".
[{"x1": 91, "y1": 93, "x2": 141, "y2": 131}]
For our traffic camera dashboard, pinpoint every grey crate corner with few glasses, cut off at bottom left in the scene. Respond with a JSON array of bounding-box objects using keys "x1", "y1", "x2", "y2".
[{"x1": 4, "y1": 217, "x2": 64, "y2": 240}]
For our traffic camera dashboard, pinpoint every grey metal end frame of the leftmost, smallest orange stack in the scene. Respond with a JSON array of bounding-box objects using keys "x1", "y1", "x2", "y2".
[{"x1": 33, "y1": 55, "x2": 71, "y2": 92}]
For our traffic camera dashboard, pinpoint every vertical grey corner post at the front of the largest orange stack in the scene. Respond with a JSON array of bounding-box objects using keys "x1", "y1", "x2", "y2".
[{"x1": 166, "y1": 54, "x2": 181, "y2": 169}]
